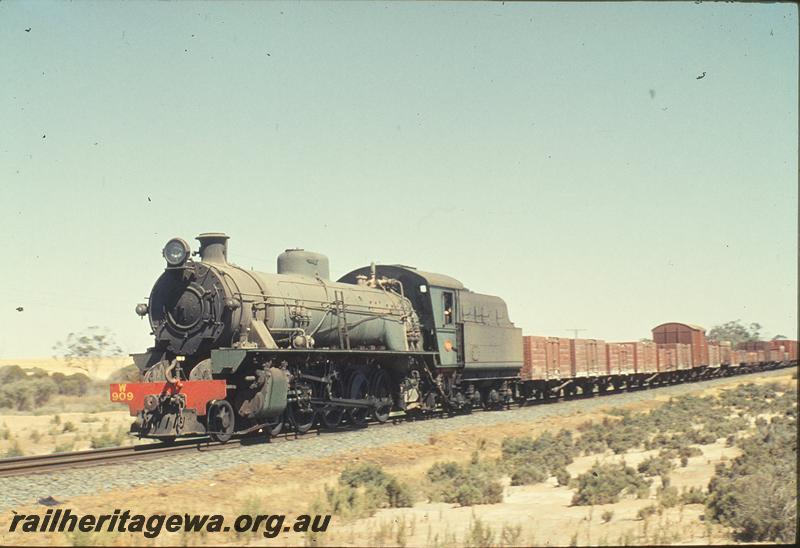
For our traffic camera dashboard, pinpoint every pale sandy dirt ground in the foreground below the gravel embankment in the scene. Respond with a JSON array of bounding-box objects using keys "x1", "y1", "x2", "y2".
[{"x1": 0, "y1": 370, "x2": 796, "y2": 546}]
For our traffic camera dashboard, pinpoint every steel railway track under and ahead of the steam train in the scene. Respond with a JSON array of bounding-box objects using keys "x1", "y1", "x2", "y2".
[{"x1": 0, "y1": 366, "x2": 787, "y2": 477}]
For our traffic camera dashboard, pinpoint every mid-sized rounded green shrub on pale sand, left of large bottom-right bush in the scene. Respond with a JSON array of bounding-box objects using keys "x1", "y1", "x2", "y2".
[{"x1": 572, "y1": 463, "x2": 652, "y2": 506}]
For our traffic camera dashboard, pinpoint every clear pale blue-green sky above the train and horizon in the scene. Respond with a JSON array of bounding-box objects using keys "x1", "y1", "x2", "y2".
[{"x1": 0, "y1": 0, "x2": 798, "y2": 359}]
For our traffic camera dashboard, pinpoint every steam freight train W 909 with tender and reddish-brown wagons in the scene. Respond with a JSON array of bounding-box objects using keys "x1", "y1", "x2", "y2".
[{"x1": 110, "y1": 233, "x2": 797, "y2": 441}]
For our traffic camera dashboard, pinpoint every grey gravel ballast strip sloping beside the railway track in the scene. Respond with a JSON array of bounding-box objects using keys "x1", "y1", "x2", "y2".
[{"x1": 0, "y1": 369, "x2": 787, "y2": 511}]
